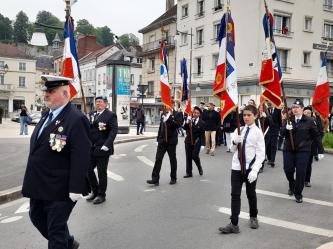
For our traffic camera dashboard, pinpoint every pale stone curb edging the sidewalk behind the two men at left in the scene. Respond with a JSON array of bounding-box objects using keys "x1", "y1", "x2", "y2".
[{"x1": 0, "y1": 136, "x2": 156, "y2": 205}]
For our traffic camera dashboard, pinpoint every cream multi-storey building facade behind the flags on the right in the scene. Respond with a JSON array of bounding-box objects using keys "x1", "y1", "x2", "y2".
[{"x1": 176, "y1": 0, "x2": 333, "y2": 104}]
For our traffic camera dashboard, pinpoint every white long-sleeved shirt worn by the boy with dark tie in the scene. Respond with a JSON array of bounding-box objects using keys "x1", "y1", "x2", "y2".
[{"x1": 230, "y1": 123, "x2": 265, "y2": 172}]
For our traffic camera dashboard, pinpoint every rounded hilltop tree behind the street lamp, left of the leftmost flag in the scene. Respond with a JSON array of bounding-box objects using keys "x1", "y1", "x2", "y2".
[{"x1": 36, "y1": 10, "x2": 64, "y2": 44}]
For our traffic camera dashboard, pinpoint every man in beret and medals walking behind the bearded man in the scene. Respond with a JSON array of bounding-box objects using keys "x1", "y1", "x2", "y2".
[{"x1": 87, "y1": 97, "x2": 118, "y2": 204}]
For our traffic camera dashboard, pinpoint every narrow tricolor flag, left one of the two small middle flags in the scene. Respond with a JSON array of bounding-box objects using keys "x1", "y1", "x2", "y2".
[{"x1": 160, "y1": 42, "x2": 172, "y2": 110}]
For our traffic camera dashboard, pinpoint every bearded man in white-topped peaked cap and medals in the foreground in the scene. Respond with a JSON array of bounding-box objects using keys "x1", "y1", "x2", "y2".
[{"x1": 22, "y1": 75, "x2": 91, "y2": 249}]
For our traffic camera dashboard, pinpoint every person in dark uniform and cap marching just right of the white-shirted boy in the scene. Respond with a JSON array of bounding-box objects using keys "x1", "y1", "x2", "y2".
[{"x1": 281, "y1": 99, "x2": 324, "y2": 203}]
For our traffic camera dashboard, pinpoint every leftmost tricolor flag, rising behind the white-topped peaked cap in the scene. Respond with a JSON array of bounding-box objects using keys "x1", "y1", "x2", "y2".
[{"x1": 61, "y1": 16, "x2": 81, "y2": 98}]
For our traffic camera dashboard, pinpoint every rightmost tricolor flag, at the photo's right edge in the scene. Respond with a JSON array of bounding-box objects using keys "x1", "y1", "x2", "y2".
[{"x1": 312, "y1": 56, "x2": 330, "y2": 119}]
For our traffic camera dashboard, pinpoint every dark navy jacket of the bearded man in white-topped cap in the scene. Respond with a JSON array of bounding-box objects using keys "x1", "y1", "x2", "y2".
[{"x1": 22, "y1": 103, "x2": 91, "y2": 201}]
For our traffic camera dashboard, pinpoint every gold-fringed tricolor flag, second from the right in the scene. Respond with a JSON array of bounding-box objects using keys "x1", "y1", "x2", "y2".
[{"x1": 259, "y1": 14, "x2": 282, "y2": 107}]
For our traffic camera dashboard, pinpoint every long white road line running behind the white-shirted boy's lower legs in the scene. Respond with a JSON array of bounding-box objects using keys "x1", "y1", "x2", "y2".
[{"x1": 218, "y1": 207, "x2": 333, "y2": 238}]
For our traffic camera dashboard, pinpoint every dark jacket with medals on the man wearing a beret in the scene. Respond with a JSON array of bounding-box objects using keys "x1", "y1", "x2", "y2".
[{"x1": 89, "y1": 109, "x2": 118, "y2": 156}]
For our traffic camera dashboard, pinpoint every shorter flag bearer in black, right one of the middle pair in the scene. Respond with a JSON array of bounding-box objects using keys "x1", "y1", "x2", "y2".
[{"x1": 184, "y1": 106, "x2": 205, "y2": 178}]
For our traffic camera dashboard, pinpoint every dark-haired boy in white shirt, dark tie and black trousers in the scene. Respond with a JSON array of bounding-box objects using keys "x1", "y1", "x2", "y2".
[{"x1": 219, "y1": 105, "x2": 265, "y2": 234}]
